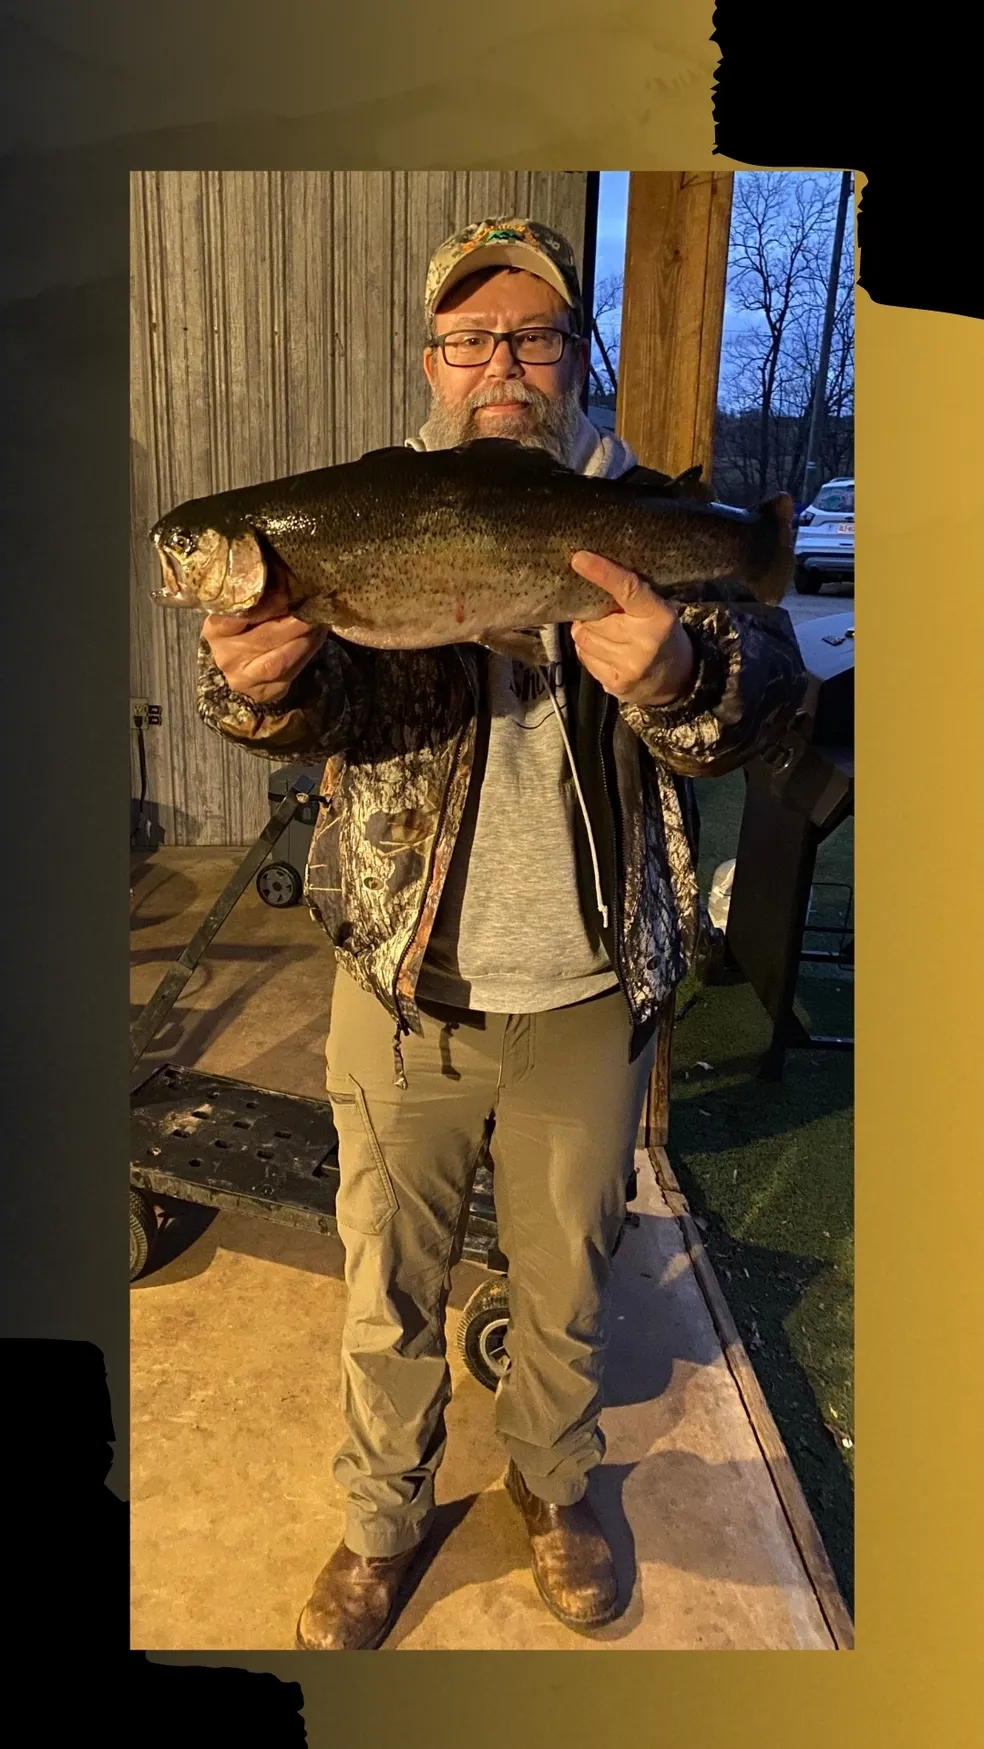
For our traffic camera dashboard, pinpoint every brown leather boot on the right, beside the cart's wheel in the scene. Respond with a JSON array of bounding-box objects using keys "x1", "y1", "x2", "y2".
[{"x1": 505, "y1": 1464, "x2": 619, "y2": 1628}]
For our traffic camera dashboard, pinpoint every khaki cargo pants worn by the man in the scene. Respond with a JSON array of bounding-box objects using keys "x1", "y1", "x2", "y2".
[{"x1": 327, "y1": 969, "x2": 654, "y2": 1555}]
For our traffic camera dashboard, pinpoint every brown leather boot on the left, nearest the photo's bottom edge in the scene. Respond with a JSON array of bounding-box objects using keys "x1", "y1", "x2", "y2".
[{"x1": 295, "y1": 1543, "x2": 421, "y2": 1651}]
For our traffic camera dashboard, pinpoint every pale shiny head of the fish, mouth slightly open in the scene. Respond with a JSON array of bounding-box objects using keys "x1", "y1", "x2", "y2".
[{"x1": 150, "y1": 505, "x2": 267, "y2": 614}]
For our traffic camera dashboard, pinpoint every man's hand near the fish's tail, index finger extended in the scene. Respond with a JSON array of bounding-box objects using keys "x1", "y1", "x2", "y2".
[{"x1": 572, "y1": 553, "x2": 696, "y2": 707}]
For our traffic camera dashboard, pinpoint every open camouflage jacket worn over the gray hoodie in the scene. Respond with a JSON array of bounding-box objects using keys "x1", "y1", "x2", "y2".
[{"x1": 197, "y1": 474, "x2": 804, "y2": 1056}]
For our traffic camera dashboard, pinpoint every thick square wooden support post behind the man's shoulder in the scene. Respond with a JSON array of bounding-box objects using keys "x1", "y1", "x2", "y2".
[{"x1": 615, "y1": 170, "x2": 734, "y2": 481}]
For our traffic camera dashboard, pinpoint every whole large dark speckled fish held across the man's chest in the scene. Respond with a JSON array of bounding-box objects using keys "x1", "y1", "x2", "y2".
[{"x1": 152, "y1": 437, "x2": 793, "y2": 654}]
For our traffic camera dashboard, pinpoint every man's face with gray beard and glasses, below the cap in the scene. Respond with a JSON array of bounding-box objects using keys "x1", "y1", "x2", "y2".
[{"x1": 423, "y1": 268, "x2": 587, "y2": 462}]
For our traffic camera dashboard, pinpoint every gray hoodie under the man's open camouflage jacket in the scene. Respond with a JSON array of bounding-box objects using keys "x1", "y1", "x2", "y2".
[{"x1": 411, "y1": 416, "x2": 636, "y2": 1014}]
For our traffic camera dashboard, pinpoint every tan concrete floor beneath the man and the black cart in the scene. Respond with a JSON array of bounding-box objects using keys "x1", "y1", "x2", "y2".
[{"x1": 131, "y1": 850, "x2": 834, "y2": 1651}]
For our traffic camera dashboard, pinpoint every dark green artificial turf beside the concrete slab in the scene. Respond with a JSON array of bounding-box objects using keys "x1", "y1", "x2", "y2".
[{"x1": 668, "y1": 773, "x2": 855, "y2": 1606}]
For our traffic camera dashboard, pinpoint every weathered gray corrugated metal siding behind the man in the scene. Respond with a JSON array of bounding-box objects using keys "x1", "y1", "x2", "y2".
[{"x1": 131, "y1": 170, "x2": 587, "y2": 845}]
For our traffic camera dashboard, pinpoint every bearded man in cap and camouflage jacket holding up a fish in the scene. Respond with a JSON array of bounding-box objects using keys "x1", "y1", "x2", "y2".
[{"x1": 199, "y1": 219, "x2": 802, "y2": 1651}]
